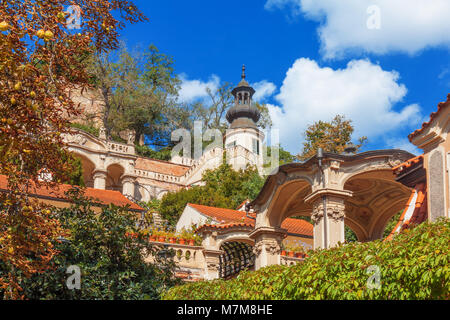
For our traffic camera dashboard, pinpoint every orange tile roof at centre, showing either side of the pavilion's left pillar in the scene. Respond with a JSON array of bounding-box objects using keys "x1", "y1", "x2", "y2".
[{"x1": 188, "y1": 203, "x2": 313, "y2": 237}]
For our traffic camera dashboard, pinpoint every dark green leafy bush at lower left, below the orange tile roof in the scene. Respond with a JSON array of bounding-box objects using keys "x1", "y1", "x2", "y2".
[{"x1": 16, "y1": 189, "x2": 179, "y2": 300}]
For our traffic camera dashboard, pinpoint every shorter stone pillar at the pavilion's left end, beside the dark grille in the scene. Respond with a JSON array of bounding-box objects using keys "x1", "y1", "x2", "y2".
[{"x1": 249, "y1": 227, "x2": 287, "y2": 270}]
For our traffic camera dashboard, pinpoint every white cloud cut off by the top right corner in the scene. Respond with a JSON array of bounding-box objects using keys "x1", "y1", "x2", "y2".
[{"x1": 265, "y1": 0, "x2": 450, "y2": 58}]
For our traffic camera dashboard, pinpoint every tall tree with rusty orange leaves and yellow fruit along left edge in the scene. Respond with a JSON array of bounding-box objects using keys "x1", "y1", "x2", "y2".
[{"x1": 0, "y1": 0, "x2": 147, "y2": 299}]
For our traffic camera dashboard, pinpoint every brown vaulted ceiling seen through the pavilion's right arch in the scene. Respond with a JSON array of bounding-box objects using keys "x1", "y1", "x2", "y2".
[{"x1": 344, "y1": 169, "x2": 411, "y2": 241}]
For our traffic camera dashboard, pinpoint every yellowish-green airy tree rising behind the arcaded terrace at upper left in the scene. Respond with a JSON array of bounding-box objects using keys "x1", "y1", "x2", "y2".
[{"x1": 88, "y1": 44, "x2": 183, "y2": 146}]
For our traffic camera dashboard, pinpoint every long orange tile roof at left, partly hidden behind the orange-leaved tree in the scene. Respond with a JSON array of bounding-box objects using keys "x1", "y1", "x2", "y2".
[{"x1": 0, "y1": 175, "x2": 145, "y2": 211}]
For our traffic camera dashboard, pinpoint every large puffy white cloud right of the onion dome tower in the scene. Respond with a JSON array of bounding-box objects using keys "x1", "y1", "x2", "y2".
[{"x1": 269, "y1": 58, "x2": 423, "y2": 153}]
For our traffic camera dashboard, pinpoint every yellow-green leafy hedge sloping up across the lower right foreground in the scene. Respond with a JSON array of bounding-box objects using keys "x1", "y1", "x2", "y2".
[{"x1": 164, "y1": 219, "x2": 450, "y2": 300}]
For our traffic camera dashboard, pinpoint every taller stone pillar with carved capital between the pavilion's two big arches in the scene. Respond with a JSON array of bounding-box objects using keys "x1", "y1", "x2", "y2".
[{"x1": 305, "y1": 189, "x2": 352, "y2": 249}]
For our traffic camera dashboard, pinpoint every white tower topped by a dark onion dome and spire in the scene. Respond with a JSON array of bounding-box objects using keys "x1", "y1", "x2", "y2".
[{"x1": 225, "y1": 66, "x2": 264, "y2": 169}]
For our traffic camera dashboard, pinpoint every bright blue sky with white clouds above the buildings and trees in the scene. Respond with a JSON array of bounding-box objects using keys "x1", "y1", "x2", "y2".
[{"x1": 118, "y1": 0, "x2": 450, "y2": 153}]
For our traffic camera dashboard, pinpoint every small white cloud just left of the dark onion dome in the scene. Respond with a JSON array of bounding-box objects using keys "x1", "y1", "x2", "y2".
[{"x1": 178, "y1": 74, "x2": 220, "y2": 102}]
